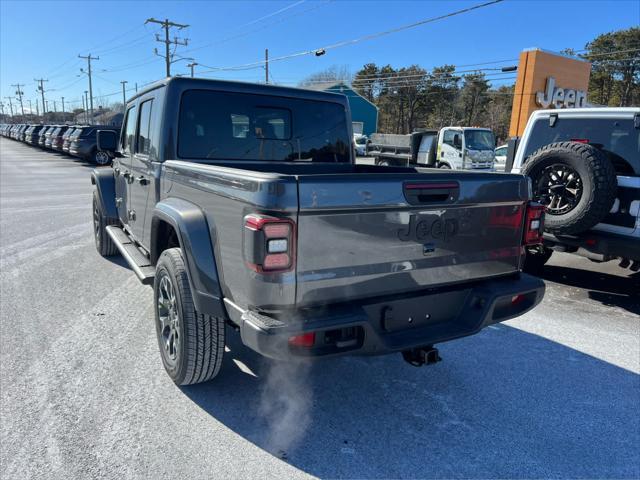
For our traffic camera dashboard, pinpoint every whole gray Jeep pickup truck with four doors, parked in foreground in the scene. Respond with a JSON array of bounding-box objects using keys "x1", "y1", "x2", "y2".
[{"x1": 92, "y1": 78, "x2": 544, "y2": 385}]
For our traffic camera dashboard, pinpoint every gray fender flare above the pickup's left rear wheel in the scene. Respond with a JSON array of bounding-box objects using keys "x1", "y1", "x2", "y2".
[{"x1": 150, "y1": 198, "x2": 227, "y2": 318}]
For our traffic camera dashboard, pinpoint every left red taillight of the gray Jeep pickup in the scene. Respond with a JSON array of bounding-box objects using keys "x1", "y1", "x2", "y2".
[{"x1": 244, "y1": 214, "x2": 296, "y2": 273}]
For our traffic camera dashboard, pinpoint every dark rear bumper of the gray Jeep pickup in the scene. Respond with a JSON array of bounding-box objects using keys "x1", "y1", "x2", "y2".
[{"x1": 228, "y1": 274, "x2": 545, "y2": 358}]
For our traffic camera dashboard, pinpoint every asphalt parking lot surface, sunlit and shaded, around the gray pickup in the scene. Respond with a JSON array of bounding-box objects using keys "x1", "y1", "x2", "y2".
[{"x1": 0, "y1": 139, "x2": 640, "y2": 479}]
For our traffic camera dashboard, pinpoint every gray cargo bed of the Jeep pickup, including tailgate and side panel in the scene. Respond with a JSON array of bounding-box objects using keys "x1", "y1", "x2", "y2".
[{"x1": 164, "y1": 161, "x2": 528, "y2": 310}]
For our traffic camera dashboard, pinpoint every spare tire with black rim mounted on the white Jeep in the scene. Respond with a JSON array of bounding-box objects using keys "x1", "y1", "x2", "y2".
[{"x1": 522, "y1": 142, "x2": 618, "y2": 234}]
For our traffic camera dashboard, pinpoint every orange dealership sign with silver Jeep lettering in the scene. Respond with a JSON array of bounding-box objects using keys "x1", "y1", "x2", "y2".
[{"x1": 509, "y1": 49, "x2": 591, "y2": 137}]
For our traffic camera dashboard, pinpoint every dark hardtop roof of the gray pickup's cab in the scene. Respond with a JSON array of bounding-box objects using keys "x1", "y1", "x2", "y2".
[{"x1": 127, "y1": 77, "x2": 346, "y2": 103}]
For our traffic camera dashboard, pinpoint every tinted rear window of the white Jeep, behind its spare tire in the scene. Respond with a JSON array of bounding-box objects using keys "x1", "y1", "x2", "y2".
[{"x1": 524, "y1": 118, "x2": 640, "y2": 173}]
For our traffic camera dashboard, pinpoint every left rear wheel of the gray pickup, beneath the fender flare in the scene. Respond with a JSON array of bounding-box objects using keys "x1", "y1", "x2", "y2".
[{"x1": 153, "y1": 248, "x2": 225, "y2": 385}]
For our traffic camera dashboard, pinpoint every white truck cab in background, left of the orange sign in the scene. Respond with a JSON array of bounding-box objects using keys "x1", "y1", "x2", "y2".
[{"x1": 437, "y1": 127, "x2": 496, "y2": 170}]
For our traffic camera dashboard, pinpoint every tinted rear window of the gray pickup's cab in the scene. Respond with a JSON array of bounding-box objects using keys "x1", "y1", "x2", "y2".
[{"x1": 178, "y1": 90, "x2": 351, "y2": 162}]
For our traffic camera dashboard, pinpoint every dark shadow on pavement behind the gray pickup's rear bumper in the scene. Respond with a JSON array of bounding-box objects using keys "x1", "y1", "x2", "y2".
[{"x1": 183, "y1": 325, "x2": 640, "y2": 478}]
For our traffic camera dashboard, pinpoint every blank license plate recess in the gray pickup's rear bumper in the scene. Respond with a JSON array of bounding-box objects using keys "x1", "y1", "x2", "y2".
[{"x1": 364, "y1": 290, "x2": 469, "y2": 333}]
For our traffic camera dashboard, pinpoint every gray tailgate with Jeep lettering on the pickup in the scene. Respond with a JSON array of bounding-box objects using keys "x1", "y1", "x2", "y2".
[{"x1": 296, "y1": 171, "x2": 528, "y2": 304}]
